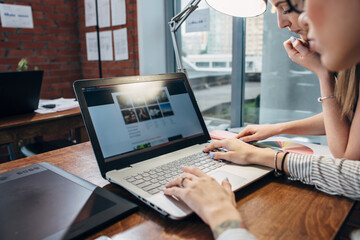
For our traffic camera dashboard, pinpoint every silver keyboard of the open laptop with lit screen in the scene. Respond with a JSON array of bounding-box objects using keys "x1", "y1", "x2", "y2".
[{"x1": 124, "y1": 152, "x2": 225, "y2": 194}]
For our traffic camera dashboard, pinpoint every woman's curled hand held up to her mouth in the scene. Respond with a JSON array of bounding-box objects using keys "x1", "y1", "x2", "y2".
[{"x1": 284, "y1": 37, "x2": 328, "y2": 77}]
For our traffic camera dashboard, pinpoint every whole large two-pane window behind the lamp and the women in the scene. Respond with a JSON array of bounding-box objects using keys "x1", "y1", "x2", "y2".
[{"x1": 171, "y1": 0, "x2": 321, "y2": 141}]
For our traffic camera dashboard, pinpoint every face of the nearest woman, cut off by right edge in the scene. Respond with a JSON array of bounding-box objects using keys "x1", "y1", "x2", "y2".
[{"x1": 305, "y1": 0, "x2": 360, "y2": 71}]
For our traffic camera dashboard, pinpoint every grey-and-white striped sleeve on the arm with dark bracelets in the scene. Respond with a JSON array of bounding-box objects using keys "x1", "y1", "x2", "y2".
[{"x1": 287, "y1": 153, "x2": 360, "y2": 200}]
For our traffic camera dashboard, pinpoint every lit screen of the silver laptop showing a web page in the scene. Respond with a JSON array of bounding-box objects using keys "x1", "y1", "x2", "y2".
[{"x1": 82, "y1": 78, "x2": 205, "y2": 162}]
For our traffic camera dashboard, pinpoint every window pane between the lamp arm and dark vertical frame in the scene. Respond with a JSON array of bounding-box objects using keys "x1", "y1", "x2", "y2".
[{"x1": 176, "y1": 0, "x2": 233, "y2": 130}]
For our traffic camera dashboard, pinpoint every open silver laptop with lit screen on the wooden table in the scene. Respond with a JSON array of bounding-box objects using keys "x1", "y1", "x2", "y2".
[{"x1": 74, "y1": 73, "x2": 271, "y2": 219}]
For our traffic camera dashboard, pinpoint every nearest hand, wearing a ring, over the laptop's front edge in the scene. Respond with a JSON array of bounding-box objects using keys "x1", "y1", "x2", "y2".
[{"x1": 163, "y1": 166, "x2": 241, "y2": 229}]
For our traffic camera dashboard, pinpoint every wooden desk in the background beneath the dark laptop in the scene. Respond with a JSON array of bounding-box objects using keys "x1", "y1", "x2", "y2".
[{"x1": 0, "y1": 108, "x2": 88, "y2": 159}]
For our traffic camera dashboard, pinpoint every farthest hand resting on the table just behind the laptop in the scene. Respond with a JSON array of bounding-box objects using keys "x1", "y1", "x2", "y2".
[{"x1": 236, "y1": 124, "x2": 280, "y2": 142}]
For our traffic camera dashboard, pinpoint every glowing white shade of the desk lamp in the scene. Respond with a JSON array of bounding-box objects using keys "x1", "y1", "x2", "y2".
[{"x1": 206, "y1": 0, "x2": 267, "y2": 17}]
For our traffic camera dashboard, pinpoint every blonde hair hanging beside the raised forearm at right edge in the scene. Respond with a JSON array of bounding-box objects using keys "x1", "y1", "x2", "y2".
[{"x1": 335, "y1": 64, "x2": 360, "y2": 121}]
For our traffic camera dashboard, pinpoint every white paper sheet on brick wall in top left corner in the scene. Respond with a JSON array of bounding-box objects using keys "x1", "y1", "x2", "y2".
[{"x1": 0, "y1": 4, "x2": 34, "y2": 28}]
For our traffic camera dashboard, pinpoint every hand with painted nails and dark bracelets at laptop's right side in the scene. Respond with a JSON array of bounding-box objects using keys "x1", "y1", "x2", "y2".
[{"x1": 204, "y1": 138, "x2": 264, "y2": 165}]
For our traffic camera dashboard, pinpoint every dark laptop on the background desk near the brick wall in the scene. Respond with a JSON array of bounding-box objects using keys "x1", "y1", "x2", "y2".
[{"x1": 0, "y1": 71, "x2": 44, "y2": 117}]
